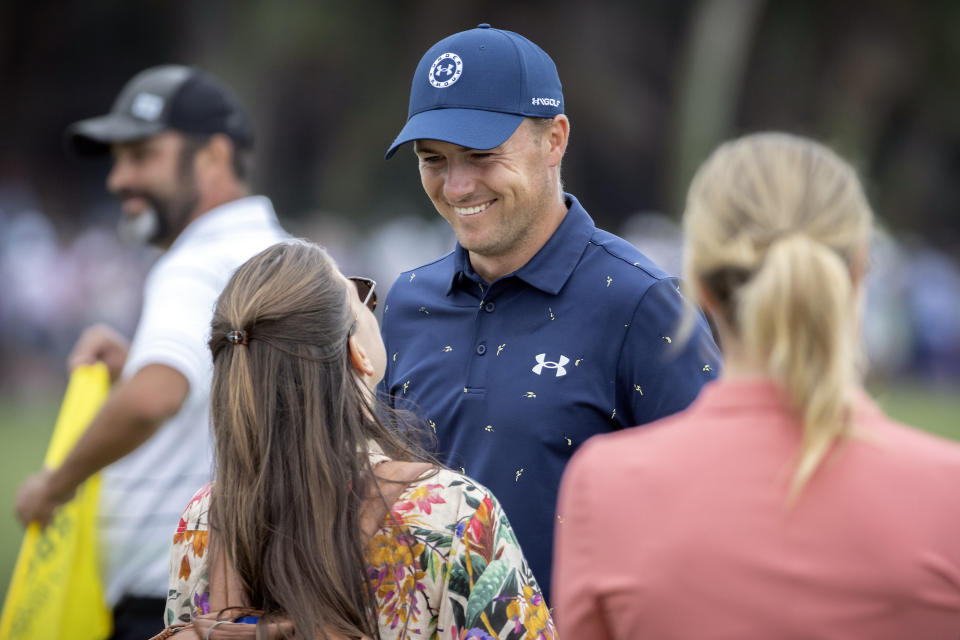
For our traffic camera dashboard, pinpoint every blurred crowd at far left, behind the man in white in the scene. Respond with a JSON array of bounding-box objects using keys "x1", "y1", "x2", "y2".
[{"x1": 0, "y1": 208, "x2": 150, "y2": 393}]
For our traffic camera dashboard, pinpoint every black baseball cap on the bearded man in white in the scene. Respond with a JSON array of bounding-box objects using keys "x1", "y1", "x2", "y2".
[{"x1": 66, "y1": 65, "x2": 253, "y2": 156}]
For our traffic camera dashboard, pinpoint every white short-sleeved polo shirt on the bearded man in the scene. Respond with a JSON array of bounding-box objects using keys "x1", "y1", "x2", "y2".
[{"x1": 99, "y1": 196, "x2": 289, "y2": 604}]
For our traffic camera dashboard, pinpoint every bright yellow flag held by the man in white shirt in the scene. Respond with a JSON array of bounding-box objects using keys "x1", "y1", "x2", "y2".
[{"x1": 0, "y1": 363, "x2": 113, "y2": 640}]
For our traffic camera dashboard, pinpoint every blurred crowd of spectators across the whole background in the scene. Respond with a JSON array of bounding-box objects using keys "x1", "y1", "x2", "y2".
[{"x1": 0, "y1": 198, "x2": 960, "y2": 395}]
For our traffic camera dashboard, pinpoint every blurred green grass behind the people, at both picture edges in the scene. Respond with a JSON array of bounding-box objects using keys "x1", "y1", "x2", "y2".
[{"x1": 0, "y1": 383, "x2": 960, "y2": 602}]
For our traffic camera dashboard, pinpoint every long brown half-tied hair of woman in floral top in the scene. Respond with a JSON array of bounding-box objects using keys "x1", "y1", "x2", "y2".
[{"x1": 210, "y1": 242, "x2": 436, "y2": 638}]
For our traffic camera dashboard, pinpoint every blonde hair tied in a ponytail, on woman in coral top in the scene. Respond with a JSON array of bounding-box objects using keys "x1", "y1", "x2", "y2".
[{"x1": 684, "y1": 133, "x2": 872, "y2": 498}]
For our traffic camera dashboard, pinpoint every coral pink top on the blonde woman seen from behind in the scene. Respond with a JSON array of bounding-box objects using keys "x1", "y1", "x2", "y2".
[{"x1": 553, "y1": 380, "x2": 960, "y2": 640}]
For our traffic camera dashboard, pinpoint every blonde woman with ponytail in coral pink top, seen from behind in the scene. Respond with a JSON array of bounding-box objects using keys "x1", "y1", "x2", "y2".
[{"x1": 553, "y1": 134, "x2": 960, "y2": 640}]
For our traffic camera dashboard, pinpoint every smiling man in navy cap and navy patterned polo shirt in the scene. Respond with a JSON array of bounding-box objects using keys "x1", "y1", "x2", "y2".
[{"x1": 383, "y1": 24, "x2": 720, "y2": 601}]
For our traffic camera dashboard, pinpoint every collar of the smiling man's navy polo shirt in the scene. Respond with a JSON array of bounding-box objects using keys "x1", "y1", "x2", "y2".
[{"x1": 447, "y1": 193, "x2": 596, "y2": 295}]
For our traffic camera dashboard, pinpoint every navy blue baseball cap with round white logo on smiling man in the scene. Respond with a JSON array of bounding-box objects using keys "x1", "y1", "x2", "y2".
[{"x1": 386, "y1": 24, "x2": 563, "y2": 158}]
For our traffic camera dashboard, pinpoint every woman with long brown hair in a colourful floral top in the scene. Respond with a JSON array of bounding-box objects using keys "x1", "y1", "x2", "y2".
[{"x1": 165, "y1": 242, "x2": 554, "y2": 639}]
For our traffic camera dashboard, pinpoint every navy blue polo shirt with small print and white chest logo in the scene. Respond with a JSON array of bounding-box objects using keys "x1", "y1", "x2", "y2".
[{"x1": 381, "y1": 195, "x2": 720, "y2": 602}]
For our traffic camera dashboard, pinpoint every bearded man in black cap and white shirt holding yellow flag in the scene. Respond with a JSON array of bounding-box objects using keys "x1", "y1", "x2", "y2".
[{"x1": 17, "y1": 65, "x2": 286, "y2": 638}]
